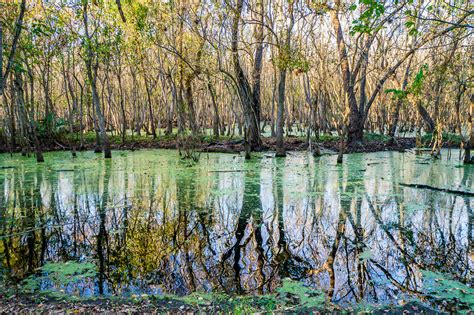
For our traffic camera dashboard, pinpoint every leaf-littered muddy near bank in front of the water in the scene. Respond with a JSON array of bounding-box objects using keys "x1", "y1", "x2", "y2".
[{"x1": 0, "y1": 294, "x2": 436, "y2": 314}]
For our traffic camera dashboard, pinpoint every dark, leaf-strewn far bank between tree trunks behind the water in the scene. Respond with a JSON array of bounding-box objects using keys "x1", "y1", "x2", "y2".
[{"x1": 0, "y1": 134, "x2": 461, "y2": 155}]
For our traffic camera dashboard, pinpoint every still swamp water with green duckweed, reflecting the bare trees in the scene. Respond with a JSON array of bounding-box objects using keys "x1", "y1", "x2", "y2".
[{"x1": 0, "y1": 150, "x2": 474, "y2": 307}]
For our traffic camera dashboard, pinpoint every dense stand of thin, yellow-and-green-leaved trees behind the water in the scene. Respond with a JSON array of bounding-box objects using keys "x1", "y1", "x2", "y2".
[{"x1": 0, "y1": 0, "x2": 474, "y2": 164}]
